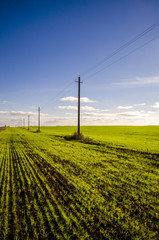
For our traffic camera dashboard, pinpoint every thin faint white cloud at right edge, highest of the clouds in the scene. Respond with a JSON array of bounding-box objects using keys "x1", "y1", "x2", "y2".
[{"x1": 114, "y1": 76, "x2": 159, "y2": 86}]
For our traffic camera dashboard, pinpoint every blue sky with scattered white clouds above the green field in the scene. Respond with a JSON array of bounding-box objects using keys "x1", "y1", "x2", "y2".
[{"x1": 0, "y1": 0, "x2": 159, "y2": 126}]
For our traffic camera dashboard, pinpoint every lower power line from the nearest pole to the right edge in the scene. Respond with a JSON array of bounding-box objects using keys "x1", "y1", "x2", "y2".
[{"x1": 83, "y1": 35, "x2": 159, "y2": 80}]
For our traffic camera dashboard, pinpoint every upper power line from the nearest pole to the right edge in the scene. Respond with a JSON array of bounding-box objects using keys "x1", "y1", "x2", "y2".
[{"x1": 81, "y1": 21, "x2": 159, "y2": 76}]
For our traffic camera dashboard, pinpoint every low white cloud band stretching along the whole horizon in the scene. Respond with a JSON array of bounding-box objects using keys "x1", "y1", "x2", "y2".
[{"x1": 0, "y1": 110, "x2": 159, "y2": 126}]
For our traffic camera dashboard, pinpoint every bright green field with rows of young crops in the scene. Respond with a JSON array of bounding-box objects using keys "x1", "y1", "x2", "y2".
[{"x1": 0, "y1": 126, "x2": 159, "y2": 240}]
